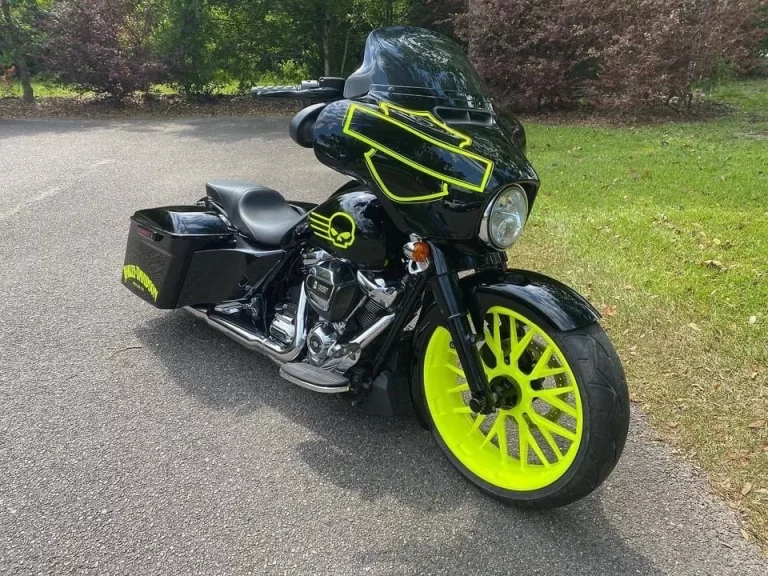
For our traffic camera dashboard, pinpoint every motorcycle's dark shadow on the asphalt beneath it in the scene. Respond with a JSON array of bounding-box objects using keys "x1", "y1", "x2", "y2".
[{"x1": 135, "y1": 312, "x2": 661, "y2": 575}]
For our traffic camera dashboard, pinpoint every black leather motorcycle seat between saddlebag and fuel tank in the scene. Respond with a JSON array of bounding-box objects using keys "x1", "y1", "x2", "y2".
[{"x1": 205, "y1": 180, "x2": 304, "y2": 246}]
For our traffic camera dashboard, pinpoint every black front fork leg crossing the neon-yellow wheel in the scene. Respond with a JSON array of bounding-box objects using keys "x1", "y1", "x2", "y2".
[{"x1": 429, "y1": 242, "x2": 495, "y2": 414}]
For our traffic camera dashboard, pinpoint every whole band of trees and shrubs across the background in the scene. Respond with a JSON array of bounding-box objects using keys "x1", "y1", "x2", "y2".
[{"x1": 0, "y1": 0, "x2": 768, "y2": 111}]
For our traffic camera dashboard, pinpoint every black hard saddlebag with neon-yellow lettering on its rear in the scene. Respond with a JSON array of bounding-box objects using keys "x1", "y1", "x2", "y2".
[{"x1": 122, "y1": 206, "x2": 237, "y2": 308}]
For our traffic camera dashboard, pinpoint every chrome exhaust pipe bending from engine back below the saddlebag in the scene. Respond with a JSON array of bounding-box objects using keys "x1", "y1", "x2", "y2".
[{"x1": 184, "y1": 285, "x2": 307, "y2": 364}]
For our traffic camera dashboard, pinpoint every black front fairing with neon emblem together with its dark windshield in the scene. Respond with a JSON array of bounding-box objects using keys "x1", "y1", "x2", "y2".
[{"x1": 314, "y1": 27, "x2": 539, "y2": 241}]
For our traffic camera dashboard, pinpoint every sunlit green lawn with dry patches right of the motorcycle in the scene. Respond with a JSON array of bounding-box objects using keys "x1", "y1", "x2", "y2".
[{"x1": 511, "y1": 81, "x2": 768, "y2": 543}]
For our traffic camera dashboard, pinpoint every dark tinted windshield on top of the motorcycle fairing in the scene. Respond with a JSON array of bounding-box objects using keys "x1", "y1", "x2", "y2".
[{"x1": 344, "y1": 26, "x2": 489, "y2": 109}]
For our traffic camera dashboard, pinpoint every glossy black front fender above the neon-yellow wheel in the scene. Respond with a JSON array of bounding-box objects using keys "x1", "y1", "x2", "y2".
[{"x1": 460, "y1": 270, "x2": 600, "y2": 331}]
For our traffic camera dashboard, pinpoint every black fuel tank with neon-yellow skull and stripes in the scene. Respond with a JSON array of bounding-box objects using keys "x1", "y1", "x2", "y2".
[{"x1": 309, "y1": 187, "x2": 407, "y2": 270}]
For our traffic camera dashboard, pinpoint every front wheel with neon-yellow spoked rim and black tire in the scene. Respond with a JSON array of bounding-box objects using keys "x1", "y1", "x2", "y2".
[{"x1": 411, "y1": 296, "x2": 629, "y2": 508}]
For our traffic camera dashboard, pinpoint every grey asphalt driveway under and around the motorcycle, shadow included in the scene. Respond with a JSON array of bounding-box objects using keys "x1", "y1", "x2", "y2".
[{"x1": 0, "y1": 119, "x2": 768, "y2": 576}]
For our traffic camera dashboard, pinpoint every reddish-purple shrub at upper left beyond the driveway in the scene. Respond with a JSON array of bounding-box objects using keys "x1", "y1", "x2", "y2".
[{"x1": 45, "y1": 0, "x2": 165, "y2": 100}]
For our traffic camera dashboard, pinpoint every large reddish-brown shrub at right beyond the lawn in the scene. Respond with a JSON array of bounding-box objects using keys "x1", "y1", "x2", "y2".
[{"x1": 457, "y1": 0, "x2": 762, "y2": 110}]
